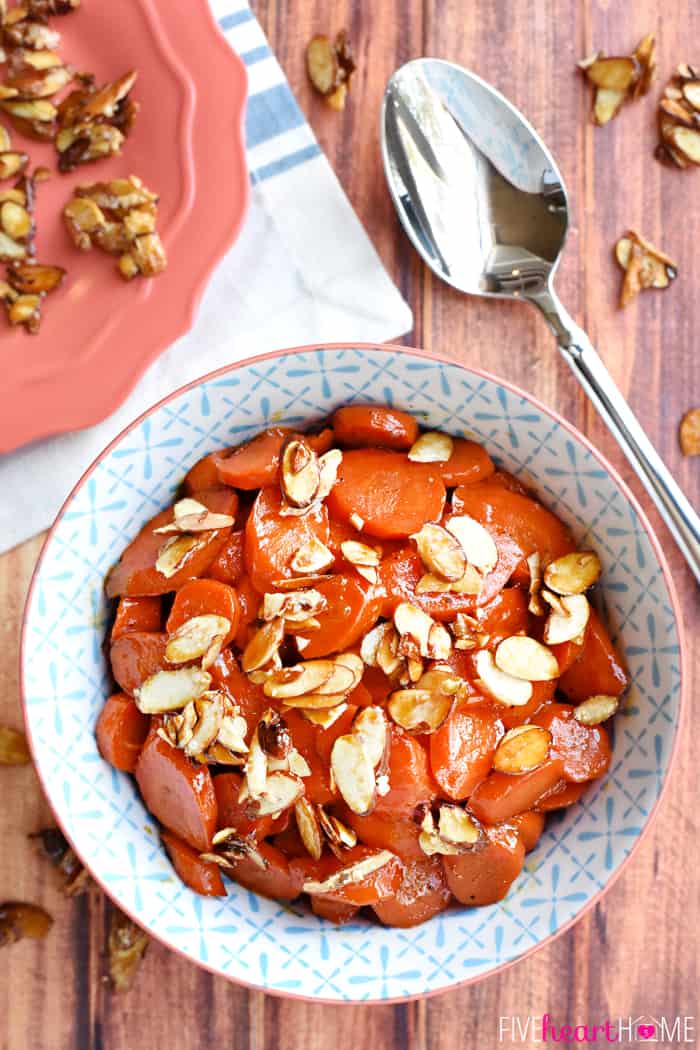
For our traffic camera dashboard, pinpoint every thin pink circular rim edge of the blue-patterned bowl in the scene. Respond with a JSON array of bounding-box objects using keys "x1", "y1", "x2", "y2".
[{"x1": 19, "y1": 341, "x2": 687, "y2": 1006}]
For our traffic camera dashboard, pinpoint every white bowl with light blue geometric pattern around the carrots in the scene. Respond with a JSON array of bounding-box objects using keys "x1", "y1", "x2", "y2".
[{"x1": 22, "y1": 345, "x2": 682, "y2": 1002}]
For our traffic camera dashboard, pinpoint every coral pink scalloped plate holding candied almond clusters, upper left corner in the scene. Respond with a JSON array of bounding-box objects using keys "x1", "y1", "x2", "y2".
[{"x1": 0, "y1": 0, "x2": 249, "y2": 452}]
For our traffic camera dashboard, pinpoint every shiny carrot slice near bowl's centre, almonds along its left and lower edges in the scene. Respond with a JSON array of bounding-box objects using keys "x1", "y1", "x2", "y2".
[{"x1": 296, "y1": 572, "x2": 382, "y2": 659}]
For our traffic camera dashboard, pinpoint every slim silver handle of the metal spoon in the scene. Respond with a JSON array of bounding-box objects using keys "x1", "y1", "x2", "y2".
[{"x1": 533, "y1": 292, "x2": 700, "y2": 583}]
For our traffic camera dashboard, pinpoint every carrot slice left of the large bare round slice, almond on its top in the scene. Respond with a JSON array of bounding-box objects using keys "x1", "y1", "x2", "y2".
[{"x1": 243, "y1": 487, "x2": 328, "y2": 594}]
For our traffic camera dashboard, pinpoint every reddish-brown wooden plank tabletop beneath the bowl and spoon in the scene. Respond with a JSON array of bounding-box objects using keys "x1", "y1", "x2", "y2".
[{"x1": 0, "y1": 0, "x2": 700, "y2": 1050}]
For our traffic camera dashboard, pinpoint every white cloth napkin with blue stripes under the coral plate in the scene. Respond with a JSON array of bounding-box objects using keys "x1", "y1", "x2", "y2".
[{"x1": 0, "y1": 0, "x2": 412, "y2": 551}]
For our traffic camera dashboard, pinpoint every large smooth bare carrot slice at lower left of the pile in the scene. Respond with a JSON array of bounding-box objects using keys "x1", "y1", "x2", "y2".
[{"x1": 135, "y1": 729, "x2": 216, "y2": 853}]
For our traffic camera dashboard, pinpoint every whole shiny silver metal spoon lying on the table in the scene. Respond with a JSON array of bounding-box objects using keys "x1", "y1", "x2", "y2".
[{"x1": 381, "y1": 59, "x2": 700, "y2": 582}]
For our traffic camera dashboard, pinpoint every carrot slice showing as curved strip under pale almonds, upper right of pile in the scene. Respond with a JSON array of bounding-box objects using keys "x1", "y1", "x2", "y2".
[{"x1": 380, "y1": 530, "x2": 523, "y2": 621}]
